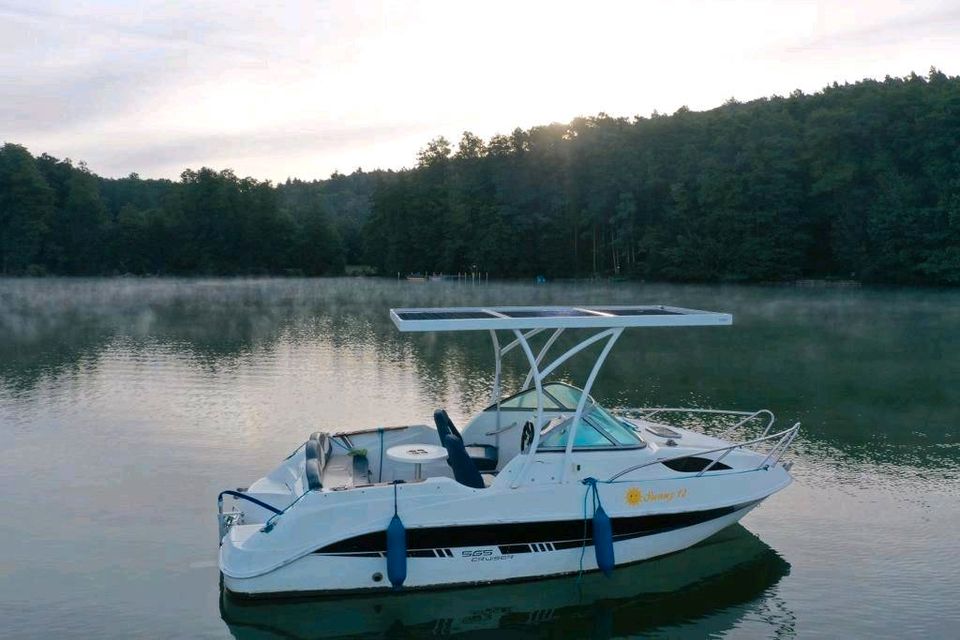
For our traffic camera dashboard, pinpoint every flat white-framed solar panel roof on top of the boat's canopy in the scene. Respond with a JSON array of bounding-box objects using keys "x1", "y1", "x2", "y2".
[{"x1": 390, "y1": 305, "x2": 733, "y2": 331}]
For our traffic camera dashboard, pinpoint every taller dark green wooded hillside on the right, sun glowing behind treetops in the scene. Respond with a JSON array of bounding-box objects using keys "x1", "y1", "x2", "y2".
[{"x1": 366, "y1": 71, "x2": 960, "y2": 284}]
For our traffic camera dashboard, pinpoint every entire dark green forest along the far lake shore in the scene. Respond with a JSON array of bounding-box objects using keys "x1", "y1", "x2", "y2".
[{"x1": 0, "y1": 69, "x2": 960, "y2": 285}]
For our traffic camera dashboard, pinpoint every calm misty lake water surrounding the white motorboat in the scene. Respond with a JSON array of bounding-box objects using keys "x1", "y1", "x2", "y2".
[{"x1": 0, "y1": 279, "x2": 960, "y2": 639}]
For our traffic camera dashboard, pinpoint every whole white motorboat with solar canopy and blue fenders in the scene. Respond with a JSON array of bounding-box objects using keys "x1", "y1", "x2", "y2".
[{"x1": 217, "y1": 305, "x2": 800, "y2": 597}]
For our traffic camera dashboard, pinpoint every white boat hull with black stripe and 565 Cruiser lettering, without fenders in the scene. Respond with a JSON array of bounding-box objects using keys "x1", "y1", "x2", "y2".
[{"x1": 219, "y1": 390, "x2": 791, "y2": 596}]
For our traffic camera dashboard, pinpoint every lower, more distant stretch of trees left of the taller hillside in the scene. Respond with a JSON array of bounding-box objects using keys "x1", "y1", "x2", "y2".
[{"x1": 0, "y1": 151, "x2": 382, "y2": 275}]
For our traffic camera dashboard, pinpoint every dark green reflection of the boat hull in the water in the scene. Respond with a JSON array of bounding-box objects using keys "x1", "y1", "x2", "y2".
[{"x1": 220, "y1": 525, "x2": 794, "y2": 640}]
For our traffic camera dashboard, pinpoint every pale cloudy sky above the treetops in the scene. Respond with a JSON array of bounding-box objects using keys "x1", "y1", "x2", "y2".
[{"x1": 0, "y1": 0, "x2": 960, "y2": 181}]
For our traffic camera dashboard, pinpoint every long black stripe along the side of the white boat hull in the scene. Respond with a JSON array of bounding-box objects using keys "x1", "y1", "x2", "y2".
[{"x1": 314, "y1": 500, "x2": 759, "y2": 558}]
